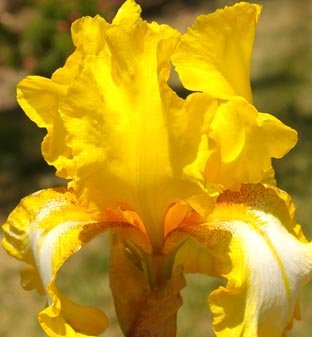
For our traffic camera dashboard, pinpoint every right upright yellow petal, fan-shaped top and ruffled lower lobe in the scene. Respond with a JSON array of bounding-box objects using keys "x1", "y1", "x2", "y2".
[{"x1": 173, "y1": 2, "x2": 297, "y2": 192}]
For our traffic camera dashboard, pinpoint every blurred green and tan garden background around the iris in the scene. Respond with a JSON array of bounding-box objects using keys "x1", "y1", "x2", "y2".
[{"x1": 0, "y1": 0, "x2": 312, "y2": 337}]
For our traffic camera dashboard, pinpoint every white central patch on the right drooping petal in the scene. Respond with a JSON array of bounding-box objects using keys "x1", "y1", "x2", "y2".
[{"x1": 218, "y1": 211, "x2": 312, "y2": 337}]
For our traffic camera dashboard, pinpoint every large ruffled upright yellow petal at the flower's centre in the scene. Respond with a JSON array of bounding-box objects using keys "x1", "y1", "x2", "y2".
[{"x1": 19, "y1": 0, "x2": 222, "y2": 247}]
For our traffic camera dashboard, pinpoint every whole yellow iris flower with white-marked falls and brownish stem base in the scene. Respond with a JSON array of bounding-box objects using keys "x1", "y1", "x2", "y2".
[{"x1": 3, "y1": 0, "x2": 312, "y2": 337}]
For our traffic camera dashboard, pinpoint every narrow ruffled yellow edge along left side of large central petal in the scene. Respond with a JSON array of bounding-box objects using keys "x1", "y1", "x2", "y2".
[{"x1": 17, "y1": 16, "x2": 109, "y2": 179}]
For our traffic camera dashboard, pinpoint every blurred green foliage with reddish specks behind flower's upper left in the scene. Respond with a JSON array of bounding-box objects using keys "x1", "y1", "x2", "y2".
[{"x1": 0, "y1": 0, "x2": 121, "y2": 76}]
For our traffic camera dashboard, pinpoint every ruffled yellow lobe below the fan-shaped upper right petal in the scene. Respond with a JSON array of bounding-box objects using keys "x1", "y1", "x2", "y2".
[{"x1": 206, "y1": 98, "x2": 297, "y2": 189}]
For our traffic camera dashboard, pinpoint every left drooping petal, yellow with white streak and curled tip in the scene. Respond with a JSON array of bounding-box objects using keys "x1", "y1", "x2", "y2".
[{"x1": 2, "y1": 188, "x2": 148, "y2": 337}]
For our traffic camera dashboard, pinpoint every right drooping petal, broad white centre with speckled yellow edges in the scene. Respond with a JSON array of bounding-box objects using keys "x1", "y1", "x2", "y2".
[{"x1": 169, "y1": 184, "x2": 312, "y2": 337}]
